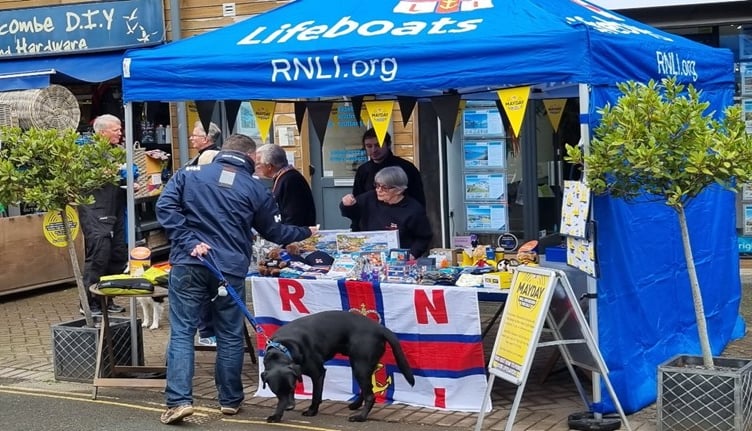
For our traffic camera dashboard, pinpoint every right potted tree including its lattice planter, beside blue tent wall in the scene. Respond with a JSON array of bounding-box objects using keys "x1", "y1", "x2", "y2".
[{"x1": 566, "y1": 79, "x2": 752, "y2": 430}]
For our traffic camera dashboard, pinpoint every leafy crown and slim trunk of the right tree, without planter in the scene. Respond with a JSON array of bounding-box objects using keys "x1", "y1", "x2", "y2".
[{"x1": 565, "y1": 79, "x2": 752, "y2": 368}]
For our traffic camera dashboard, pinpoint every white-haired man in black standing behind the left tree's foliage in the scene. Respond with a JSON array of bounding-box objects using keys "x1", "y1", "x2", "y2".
[{"x1": 79, "y1": 114, "x2": 128, "y2": 315}]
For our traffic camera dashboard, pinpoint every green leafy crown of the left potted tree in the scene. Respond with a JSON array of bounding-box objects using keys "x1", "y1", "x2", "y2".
[{"x1": 0, "y1": 127, "x2": 125, "y2": 211}]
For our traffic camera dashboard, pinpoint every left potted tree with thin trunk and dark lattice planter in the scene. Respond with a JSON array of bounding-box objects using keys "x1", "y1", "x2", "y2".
[{"x1": 0, "y1": 127, "x2": 140, "y2": 381}]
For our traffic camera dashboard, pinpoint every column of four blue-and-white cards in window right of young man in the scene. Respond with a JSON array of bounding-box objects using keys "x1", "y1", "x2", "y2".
[{"x1": 460, "y1": 103, "x2": 509, "y2": 233}]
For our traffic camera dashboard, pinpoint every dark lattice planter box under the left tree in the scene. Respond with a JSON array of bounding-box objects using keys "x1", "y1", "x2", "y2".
[{"x1": 51, "y1": 317, "x2": 144, "y2": 383}]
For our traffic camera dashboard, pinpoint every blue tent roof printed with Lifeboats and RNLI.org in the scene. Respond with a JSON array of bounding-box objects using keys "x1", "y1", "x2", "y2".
[{"x1": 123, "y1": 0, "x2": 734, "y2": 101}]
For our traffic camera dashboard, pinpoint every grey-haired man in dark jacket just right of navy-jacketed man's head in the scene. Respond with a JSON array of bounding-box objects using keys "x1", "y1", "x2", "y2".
[{"x1": 256, "y1": 144, "x2": 316, "y2": 226}]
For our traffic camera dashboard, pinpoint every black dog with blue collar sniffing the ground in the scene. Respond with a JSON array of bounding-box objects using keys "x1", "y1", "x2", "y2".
[{"x1": 261, "y1": 311, "x2": 415, "y2": 422}]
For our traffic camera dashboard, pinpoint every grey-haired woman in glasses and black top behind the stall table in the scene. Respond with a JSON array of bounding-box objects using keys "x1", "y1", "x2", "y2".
[{"x1": 339, "y1": 166, "x2": 432, "y2": 258}]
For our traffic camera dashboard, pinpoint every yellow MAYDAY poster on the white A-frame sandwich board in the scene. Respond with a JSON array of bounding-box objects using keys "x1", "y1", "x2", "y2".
[{"x1": 490, "y1": 267, "x2": 553, "y2": 383}]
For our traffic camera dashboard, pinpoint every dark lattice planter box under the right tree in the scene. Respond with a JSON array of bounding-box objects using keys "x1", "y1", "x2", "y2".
[{"x1": 657, "y1": 355, "x2": 752, "y2": 431}]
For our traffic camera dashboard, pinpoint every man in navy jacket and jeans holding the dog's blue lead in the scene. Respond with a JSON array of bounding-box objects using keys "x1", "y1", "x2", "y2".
[{"x1": 157, "y1": 135, "x2": 317, "y2": 424}]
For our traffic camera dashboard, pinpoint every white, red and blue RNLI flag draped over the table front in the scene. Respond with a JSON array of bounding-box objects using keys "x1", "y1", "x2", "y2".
[{"x1": 251, "y1": 277, "x2": 491, "y2": 412}]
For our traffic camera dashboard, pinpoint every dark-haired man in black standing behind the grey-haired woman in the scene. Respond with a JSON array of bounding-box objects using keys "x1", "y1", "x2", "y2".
[{"x1": 351, "y1": 128, "x2": 426, "y2": 231}]
